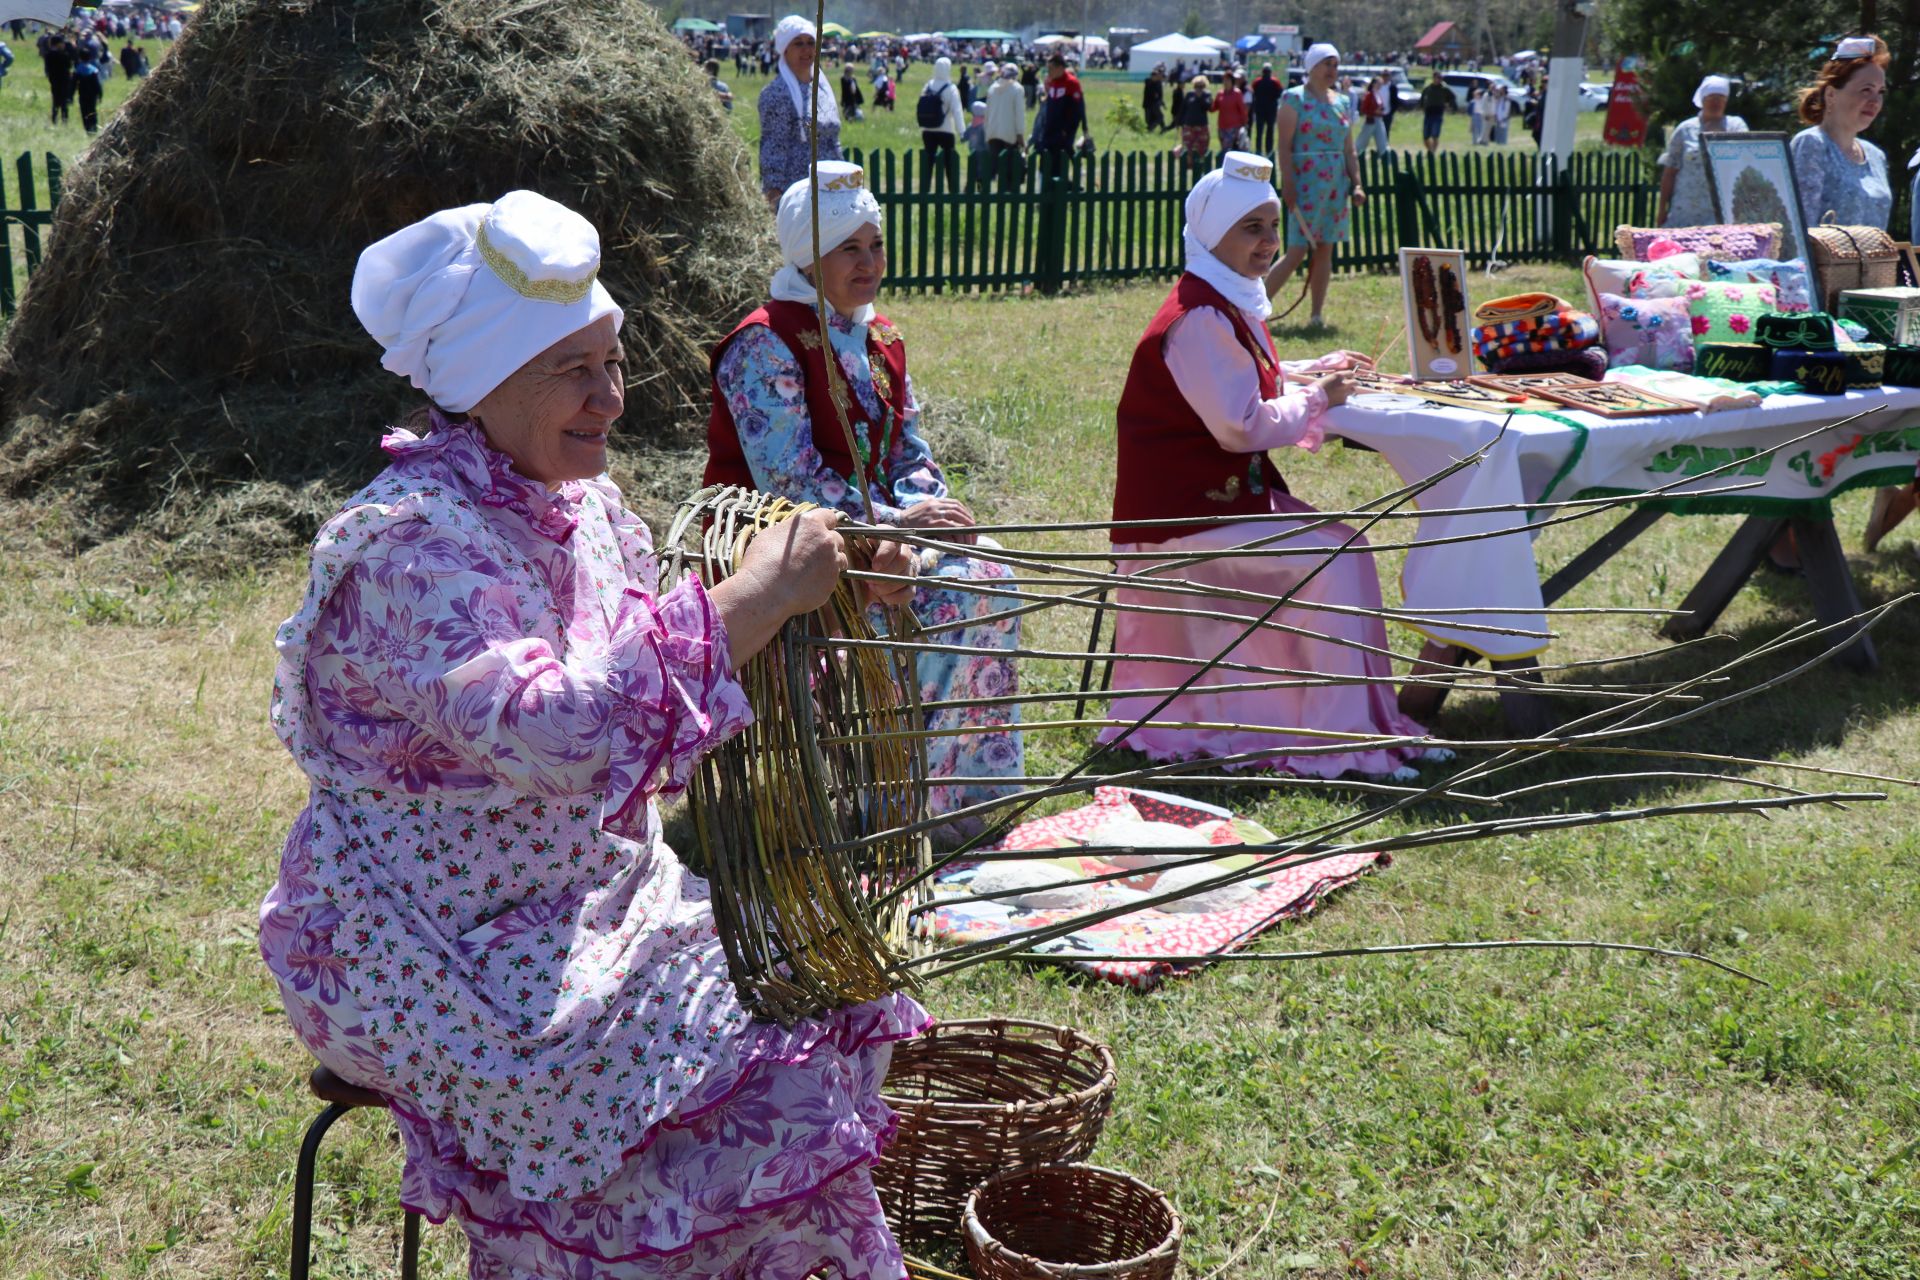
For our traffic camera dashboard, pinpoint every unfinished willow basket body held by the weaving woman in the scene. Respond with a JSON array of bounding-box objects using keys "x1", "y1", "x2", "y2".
[{"x1": 660, "y1": 486, "x2": 927, "y2": 1025}]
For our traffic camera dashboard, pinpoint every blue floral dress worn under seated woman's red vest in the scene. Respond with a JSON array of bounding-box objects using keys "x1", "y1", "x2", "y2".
[{"x1": 714, "y1": 315, "x2": 1025, "y2": 833}]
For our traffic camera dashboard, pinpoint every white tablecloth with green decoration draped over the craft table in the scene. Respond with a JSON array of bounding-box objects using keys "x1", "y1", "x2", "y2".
[{"x1": 1327, "y1": 388, "x2": 1920, "y2": 658}]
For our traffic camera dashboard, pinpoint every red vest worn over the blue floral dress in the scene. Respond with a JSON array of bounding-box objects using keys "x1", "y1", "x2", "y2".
[{"x1": 707, "y1": 301, "x2": 906, "y2": 489}]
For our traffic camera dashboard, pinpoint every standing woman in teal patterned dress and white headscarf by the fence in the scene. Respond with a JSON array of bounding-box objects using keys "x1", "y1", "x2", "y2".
[{"x1": 1267, "y1": 44, "x2": 1367, "y2": 328}]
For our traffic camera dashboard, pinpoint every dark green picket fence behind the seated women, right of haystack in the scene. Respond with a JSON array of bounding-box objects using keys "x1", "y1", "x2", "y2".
[{"x1": 849, "y1": 152, "x2": 1659, "y2": 292}]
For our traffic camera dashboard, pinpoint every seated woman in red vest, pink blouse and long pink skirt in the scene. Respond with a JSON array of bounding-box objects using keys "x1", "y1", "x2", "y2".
[{"x1": 1102, "y1": 152, "x2": 1425, "y2": 779}]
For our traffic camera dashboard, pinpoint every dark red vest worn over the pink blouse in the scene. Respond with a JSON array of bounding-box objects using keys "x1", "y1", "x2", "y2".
[{"x1": 1110, "y1": 274, "x2": 1286, "y2": 543}]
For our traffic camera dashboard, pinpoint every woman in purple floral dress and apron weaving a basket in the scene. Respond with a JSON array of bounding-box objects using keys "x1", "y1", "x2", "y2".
[{"x1": 261, "y1": 192, "x2": 927, "y2": 1280}]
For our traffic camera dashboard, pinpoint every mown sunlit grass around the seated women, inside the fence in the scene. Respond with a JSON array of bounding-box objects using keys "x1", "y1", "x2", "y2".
[{"x1": 0, "y1": 271, "x2": 1920, "y2": 1280}]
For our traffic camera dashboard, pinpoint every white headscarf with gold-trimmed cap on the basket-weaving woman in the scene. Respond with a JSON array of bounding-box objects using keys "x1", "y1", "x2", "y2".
[{"x1": 353, "y1": 192, "x2": 622, "y2": 413}]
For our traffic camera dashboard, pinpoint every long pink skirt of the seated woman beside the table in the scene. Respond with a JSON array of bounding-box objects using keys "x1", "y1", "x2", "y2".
[{"x1": 1100, "y1": 493, "x2": 1427, "y2": 777}]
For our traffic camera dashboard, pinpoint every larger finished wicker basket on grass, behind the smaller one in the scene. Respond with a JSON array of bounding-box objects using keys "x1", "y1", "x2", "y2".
[{"x1": 874, "y1": 1017, "x2": 1114, "y2": 1242}]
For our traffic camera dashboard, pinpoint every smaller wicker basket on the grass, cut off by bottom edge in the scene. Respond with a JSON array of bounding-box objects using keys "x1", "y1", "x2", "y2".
[{"x1": 962, "y1": 1165, "x2": 1183, "y2": 1280}]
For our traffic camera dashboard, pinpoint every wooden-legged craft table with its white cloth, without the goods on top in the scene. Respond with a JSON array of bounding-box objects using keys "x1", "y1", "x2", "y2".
[{"x1": 1327, "y1": 388, "x2": 1920, "y2": 727}]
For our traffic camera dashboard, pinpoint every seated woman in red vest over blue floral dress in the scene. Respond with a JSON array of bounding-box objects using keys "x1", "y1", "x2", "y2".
[{"x1": 707, "y1": 161, "x2": 1023, "y2": 835}]
